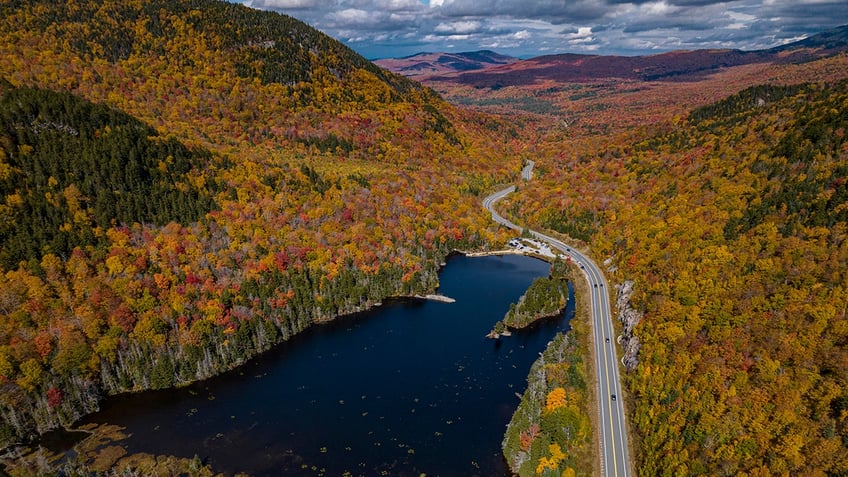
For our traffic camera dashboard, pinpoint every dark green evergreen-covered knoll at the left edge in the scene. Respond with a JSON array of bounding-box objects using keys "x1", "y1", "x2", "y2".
[{"x1": 0, "y1": 87, "x2": 219, "y2": 270}]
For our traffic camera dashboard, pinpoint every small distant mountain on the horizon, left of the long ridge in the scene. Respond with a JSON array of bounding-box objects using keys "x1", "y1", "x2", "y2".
[{"x1": 374, "y1": 50, "x2": 518, "y2": 77}]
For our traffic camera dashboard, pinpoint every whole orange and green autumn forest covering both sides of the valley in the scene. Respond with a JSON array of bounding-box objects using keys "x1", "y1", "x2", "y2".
[{"x1": 0, "y1": 0, "x2": 848, "y2": 476}]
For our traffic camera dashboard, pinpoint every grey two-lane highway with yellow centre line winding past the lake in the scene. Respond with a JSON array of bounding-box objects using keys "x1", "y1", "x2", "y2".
[{"x1": 483, "y1": 161, "x2": 630, "y2": 477}]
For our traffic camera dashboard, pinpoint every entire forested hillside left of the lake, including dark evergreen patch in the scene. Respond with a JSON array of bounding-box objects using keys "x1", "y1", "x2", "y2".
[{"x1": 0, "y1": 0, "x2": 520, "y2": 445}]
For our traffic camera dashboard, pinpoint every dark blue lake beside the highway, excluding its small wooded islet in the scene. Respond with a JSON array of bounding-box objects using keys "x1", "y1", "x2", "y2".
[{"x1": 79, "y1": 256, "x2": 573, "y2": 477}]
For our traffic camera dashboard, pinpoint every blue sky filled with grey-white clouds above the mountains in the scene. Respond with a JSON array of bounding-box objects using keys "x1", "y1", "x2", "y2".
[{"x1": 237, "y1": 0, "x2": 848, "y2": 59}]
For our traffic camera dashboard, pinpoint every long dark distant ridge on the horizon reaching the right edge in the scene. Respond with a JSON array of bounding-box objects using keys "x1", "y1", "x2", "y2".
[{"x1": 427, "y1": 25, "x2": 848, "y2": 89}]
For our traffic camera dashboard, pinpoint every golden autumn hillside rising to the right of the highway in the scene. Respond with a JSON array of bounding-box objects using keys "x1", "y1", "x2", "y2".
[{"x1": 503, "y1": 69, "x2": 848, "y2": 475}]
